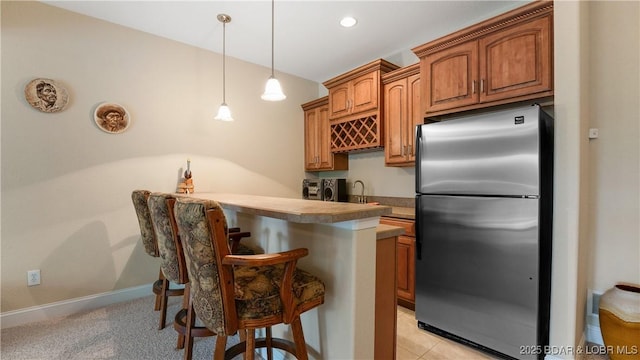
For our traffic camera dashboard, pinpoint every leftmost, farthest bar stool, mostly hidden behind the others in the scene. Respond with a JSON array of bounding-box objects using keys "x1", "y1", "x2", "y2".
[{"x1": 131, "y1": 190, "x2": 184, "y2": 330}]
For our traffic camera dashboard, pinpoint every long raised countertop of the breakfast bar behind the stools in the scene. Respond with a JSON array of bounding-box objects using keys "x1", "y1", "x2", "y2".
[{"x1": 184, "y1": 193, "x2": 392, "y2": 224}]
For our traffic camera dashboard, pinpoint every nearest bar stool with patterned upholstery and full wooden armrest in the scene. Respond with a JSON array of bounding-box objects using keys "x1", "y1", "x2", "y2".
[{"x1": 174, "y1": 198, "x2": 325, "y2": 360}]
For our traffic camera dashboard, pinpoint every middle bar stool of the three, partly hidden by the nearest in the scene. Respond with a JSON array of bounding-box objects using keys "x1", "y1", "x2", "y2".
[{"x1": 147, "y1": 192, "x2": 253, "y2": 360}]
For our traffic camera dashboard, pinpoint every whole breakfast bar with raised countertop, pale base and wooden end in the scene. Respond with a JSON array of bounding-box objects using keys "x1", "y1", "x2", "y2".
[{"x1": 186, "y1": 193, "x2": 404, "y2": 360}]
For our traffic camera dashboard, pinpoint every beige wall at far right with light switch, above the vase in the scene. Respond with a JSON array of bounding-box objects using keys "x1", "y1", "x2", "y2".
[{"x1": 589, "y1": 1, "x2": 640, "y2": 291}]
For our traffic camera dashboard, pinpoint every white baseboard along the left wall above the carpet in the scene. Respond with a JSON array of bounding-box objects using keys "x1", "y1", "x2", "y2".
[{"x1": 0, "y1": 284, "x2": 153, "y2": 329}]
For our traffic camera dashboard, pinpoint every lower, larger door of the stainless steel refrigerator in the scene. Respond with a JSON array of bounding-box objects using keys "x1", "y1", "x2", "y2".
[{"x1": 415, "y1": 195, "x2": 539, "y2": 359}]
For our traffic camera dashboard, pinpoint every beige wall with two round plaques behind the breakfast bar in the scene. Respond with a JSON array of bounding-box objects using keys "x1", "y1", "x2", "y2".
[{"x1": 1, "y1": 1, "x2": 318, "y2": 312}]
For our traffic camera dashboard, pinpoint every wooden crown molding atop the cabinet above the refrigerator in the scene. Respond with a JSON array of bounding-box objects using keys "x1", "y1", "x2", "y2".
[{"x1": 411, "y1": 0, "x2": 553, "y2": 58}]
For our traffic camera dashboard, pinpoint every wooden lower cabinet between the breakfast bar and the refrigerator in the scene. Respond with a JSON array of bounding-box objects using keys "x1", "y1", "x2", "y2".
[{"x1": 380, "y1": 216, "x2": 416, "y2": 310}]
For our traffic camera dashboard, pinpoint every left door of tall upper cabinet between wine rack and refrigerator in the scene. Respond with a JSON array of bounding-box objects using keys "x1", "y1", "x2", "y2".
[{"x1": 384, "y1": 78, "x2": 407, "y2": 165}]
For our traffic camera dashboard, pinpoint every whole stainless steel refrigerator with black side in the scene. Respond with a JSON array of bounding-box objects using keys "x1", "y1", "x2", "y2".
[{"x1": 415, "y1": 105, "x2": 553, "y2": 359}]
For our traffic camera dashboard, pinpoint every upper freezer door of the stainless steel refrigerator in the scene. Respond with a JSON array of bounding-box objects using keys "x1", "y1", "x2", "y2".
[{"x1": 416, "y1": 106, "x2": 541, "y2": 196}]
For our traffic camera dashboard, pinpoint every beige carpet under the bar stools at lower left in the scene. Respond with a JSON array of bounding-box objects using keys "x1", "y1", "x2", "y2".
[{"x1": 0, "y1": 296, "x2": 238, "y2": 360}]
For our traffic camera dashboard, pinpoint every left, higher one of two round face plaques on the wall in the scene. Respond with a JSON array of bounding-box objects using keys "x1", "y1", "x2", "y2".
[{"x1": 24, "y1": 78, "x2": 69, "y2": 113}]
